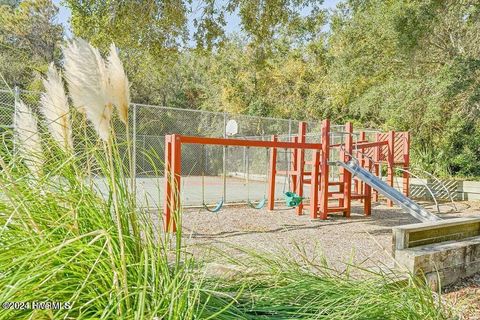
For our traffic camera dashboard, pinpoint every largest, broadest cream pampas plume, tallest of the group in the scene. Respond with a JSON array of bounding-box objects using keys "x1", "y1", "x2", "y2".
[{"x1": 63, "y1": 39, "x2": 112, "y2": 141}]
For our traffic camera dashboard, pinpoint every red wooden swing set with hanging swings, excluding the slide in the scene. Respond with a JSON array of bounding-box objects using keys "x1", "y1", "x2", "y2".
[{"x1": 163, "y1": 119, "x2": 410, "y2": 231}]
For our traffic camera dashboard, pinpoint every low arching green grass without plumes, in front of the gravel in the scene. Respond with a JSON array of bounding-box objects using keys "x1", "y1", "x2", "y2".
[{"x1": 209, "y1": 249, "x2": 450, "y2": 320}]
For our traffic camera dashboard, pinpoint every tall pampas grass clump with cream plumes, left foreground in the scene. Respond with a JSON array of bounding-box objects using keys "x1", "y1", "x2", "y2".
[{"x1": 0, "y1": 40, "x2": 231, "y2": 320}]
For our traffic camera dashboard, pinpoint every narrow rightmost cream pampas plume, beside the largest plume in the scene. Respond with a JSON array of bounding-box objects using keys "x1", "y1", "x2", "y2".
[{"x1": 107, "y1": 43, "x2": 130, "y2": 125}]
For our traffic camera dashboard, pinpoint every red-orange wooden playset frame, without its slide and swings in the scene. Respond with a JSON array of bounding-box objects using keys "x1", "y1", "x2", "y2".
[{"x1": 163, "y1": 119, "x2": 410, "y2": 231}]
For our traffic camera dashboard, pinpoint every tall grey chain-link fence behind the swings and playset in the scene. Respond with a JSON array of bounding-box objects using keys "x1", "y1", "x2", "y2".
[{"x1": 0, "y1": 89, "x2": 458, "y2": 207}]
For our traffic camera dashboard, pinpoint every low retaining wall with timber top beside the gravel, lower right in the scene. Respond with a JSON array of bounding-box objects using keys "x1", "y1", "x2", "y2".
[{"x1": 392, "y1": 218, "x2": 480, "y2": 290}]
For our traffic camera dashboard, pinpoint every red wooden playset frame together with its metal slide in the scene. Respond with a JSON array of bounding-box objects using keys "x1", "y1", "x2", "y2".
[{"x1": 163, "y1": 119, "x2": 439, "y2": 231}]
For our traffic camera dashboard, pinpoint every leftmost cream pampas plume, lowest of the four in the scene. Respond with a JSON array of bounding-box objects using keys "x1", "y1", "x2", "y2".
[{"x1": 14, "y1": 101, "x2": 43, "y2": 177}]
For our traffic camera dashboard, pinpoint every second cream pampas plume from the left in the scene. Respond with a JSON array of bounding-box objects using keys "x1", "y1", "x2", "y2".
[{"x1": 40, "y1": 63, "x2": 73, "y2": 151}]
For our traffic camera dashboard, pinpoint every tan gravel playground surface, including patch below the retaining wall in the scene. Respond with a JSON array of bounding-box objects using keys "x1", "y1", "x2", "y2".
[{"x1": 183, "y1": 201, "x2": 480, "y2": 320}]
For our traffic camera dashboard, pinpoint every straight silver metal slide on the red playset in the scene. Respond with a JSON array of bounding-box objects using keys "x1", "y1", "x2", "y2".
[{"x1": 335, "y1": 159, "x2": 442, "y2": 222}]
